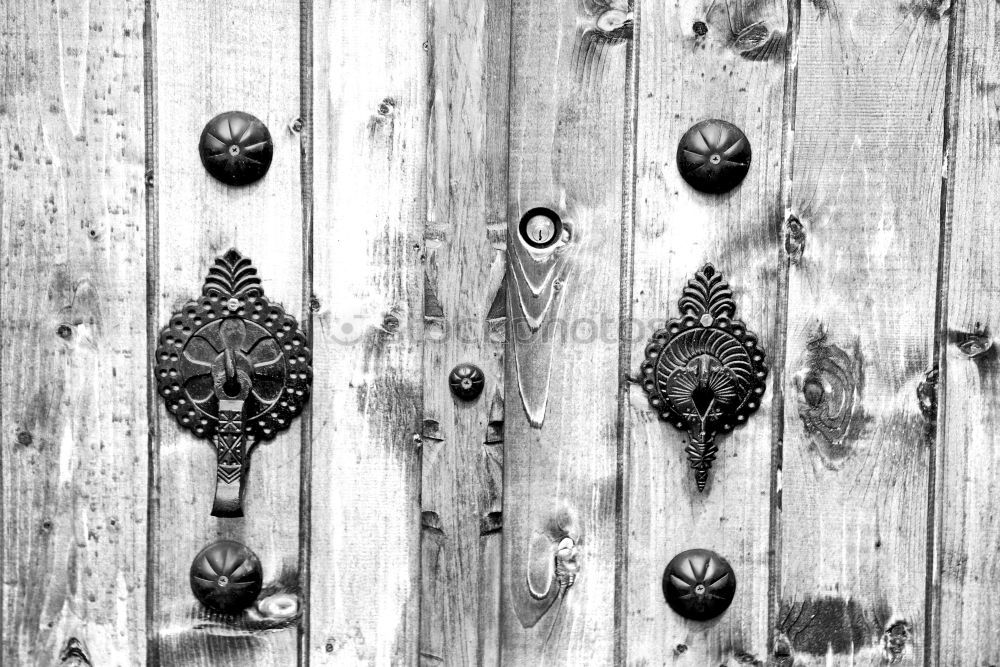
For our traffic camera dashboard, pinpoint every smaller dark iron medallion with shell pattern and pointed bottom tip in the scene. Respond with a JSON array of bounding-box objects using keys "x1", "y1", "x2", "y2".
[{"x1": 641, "y1": 264, "x2": 767, "y2": 491}]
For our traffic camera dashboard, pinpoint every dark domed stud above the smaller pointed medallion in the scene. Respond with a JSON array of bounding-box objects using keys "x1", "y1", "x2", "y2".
[{"x1": 677, "y1": 119, "x2": 750, "y2": 194}]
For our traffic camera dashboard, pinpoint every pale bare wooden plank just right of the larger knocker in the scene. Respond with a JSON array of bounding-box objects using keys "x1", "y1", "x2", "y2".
[{"x1": 309, "y1": 0, "x2": 431, "y2": 666}]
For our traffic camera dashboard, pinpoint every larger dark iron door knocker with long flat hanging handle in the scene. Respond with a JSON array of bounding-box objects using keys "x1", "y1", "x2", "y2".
[{"x1": 154, "y1": 249, "x2": 312, "y2": 517}]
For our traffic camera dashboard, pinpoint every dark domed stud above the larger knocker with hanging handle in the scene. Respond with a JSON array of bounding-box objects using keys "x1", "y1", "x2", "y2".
[{"x1": 198, "y1": 111, "x2": 274, "y2": 185}]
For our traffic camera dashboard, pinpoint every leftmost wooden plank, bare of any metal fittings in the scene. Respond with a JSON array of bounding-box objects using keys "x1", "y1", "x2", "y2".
[{"x1": 0, "y1": 0, "x2": 147, "y2": 667}]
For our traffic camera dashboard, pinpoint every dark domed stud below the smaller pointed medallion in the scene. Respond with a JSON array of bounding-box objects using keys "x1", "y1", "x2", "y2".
[{"x1": 663, "y1": 549, "x2": 736, "y2": 621}]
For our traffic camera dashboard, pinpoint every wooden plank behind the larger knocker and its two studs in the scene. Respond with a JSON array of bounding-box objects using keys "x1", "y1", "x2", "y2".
[{"x1": 152, "y1": 0, "x2": 303, "y2": 667}]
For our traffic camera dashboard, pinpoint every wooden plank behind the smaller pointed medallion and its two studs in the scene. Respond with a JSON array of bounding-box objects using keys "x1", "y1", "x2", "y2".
[{"x1": 627, "y1": 0, "x2": 787, "y2": 665}]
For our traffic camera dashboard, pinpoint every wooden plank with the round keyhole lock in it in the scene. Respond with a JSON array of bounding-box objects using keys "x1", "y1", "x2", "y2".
[{"x1": 502, "y1": 0, "x2": 632, "y2": 664}]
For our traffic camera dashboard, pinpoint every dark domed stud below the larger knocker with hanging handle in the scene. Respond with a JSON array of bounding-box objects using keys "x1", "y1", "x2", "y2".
[{"x1": 191, "y1": 540, "x2": 263, "y2": 614}]
